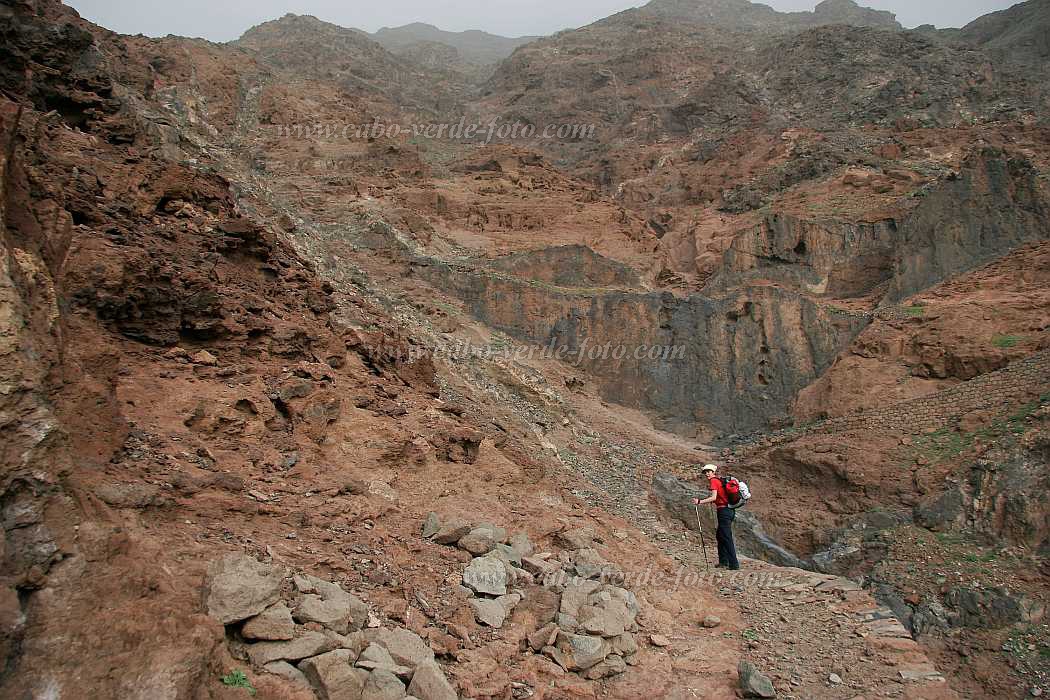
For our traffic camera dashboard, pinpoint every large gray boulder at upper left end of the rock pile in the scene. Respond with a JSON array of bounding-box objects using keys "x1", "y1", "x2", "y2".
[{"x1": 205, "y1": 554, "x2": 281, "y2": 624}]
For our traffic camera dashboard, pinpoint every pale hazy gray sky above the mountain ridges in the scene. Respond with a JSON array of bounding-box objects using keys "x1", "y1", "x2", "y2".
[{"x1": 66, "y1": 0, "x2": 1014, "y2": 41}]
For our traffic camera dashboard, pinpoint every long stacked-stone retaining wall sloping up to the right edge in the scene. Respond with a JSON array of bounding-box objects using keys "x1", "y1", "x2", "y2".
[{"x1": 773, "y1": 351, "x2": 1050, "y2": 443}]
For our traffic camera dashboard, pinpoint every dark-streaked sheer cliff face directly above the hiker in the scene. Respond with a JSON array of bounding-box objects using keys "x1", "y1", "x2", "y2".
[{"x1": 420, "y1": 264, "x2": 867, "y2": 437}]
